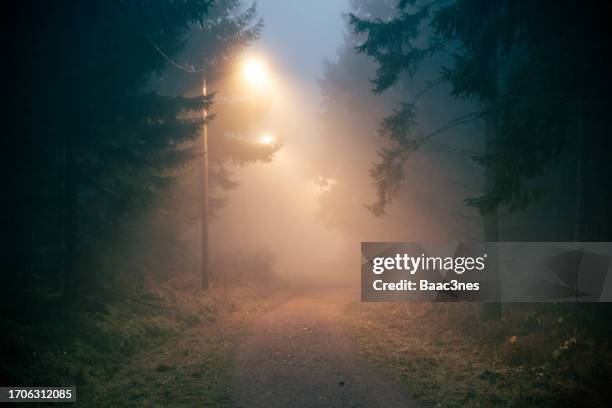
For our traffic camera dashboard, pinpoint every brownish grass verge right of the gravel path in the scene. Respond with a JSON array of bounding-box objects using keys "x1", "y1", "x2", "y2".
[{"x1": 347, "y1": 303, "x2": 612, "y2": 407}]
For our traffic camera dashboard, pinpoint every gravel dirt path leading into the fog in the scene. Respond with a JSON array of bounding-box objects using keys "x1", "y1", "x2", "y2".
[{"x1": 232, "y1": 291, "x2": 422, "y2": 408}]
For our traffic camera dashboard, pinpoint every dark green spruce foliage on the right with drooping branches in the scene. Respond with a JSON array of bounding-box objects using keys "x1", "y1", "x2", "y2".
[{"x1": 352, "y1": 0, "x2": 611, "y2": 239}]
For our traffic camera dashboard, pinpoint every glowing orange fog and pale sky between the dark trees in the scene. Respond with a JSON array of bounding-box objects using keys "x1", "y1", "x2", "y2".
[{"x1": 211, "y1": 1, "x2": 478, "y2": 284}]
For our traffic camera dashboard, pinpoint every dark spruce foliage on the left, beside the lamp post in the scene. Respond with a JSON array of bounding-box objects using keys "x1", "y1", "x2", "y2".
[{"x1": 11, "y1": 0, "x2": 268, "y2": 306}]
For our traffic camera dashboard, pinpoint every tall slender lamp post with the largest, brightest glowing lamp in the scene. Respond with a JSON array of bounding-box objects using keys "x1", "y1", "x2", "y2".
[{"x1": 200, "y1": 60, "x2": 268, "y2": 290}]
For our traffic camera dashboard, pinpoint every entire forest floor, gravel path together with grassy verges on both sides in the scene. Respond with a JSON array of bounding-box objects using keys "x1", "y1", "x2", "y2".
[{"x1": 5, "y1": 284, "x2": 612, "y2": 408}]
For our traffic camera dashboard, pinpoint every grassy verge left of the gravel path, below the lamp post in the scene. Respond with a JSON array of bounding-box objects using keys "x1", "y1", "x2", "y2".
[{"x1": 0, "y1": 278, "x2": 282, "y2": 407}]
